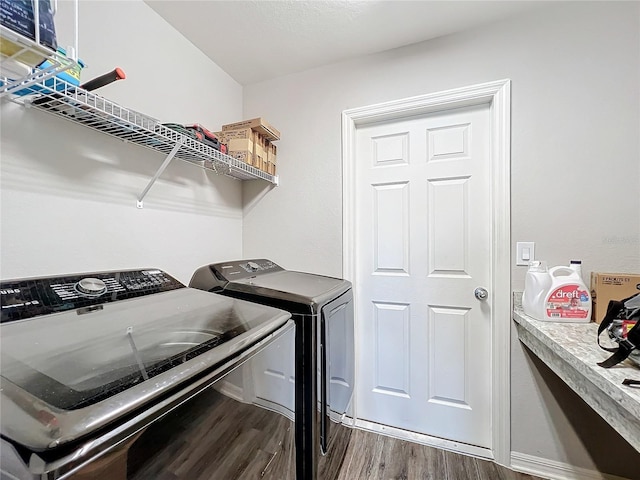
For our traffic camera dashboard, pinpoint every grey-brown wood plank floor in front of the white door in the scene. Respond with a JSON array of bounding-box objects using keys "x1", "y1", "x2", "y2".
[{"x1": 338, "y1": 429, "x2": 544, "y2": 480}]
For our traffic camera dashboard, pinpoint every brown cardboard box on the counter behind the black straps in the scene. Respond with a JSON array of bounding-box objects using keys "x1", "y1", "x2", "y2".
[{"x1": 591, "y1": 272, "x2": 640, "y2": 323}]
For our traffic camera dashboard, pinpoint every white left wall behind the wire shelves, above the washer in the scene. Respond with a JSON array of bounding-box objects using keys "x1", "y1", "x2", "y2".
[{"x1": 0, "y1": 0, "x2": 242, "y2": 283}]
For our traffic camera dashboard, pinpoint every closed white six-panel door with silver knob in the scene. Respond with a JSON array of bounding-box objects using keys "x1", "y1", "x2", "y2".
[{"x1": 354, "y1": 105, "x2": 492, "y2": 449}]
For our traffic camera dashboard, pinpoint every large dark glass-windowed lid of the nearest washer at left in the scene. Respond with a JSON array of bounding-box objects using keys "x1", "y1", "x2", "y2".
[{"x1": 0, "y1": 288, "x2": 290, "y2": 451}]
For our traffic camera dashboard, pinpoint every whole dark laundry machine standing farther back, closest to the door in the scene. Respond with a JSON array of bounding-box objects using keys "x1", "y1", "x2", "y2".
[{"x1": 189, "y1": 259, "x2": 355, "y2": 480}]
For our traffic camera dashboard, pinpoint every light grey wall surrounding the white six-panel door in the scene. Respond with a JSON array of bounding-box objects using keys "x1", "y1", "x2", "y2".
[{"x1": 243, "y1": 2, "x2": 640, "y2": 478}]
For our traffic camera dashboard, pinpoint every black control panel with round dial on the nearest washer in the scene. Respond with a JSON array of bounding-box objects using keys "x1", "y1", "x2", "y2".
[{"x1": 0, "y1": 269, "x2": 186, "y2": 323}]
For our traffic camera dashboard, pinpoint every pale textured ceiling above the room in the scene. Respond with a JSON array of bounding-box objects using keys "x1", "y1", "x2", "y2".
[{"x1": 145, "y1": 0, "x2": 545, "y2": 85}]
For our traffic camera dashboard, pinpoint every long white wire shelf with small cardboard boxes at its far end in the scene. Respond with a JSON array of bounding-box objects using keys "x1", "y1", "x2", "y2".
[{"x1": 3, "y1": 77, "x2": 278, "y2": 188}]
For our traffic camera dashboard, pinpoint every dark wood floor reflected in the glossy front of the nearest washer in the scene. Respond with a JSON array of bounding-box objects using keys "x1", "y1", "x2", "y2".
[{"x1": 128, "y1": 389, "x2": 295, "y2": 480}]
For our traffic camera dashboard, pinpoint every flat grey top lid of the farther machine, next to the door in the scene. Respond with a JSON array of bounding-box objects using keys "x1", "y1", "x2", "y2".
[{"x1": 225, "y1": 270, "x2": 351, "y2": 305}]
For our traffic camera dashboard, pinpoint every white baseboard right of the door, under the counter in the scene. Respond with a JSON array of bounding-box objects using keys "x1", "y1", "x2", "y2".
[{"x1": 511, "y1": 452, "x2": 628, "y2": 480}]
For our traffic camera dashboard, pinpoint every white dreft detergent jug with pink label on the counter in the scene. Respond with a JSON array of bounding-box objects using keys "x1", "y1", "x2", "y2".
[{"x1": 543, "y1": 266, "x2": 591, "y2": 322}]
